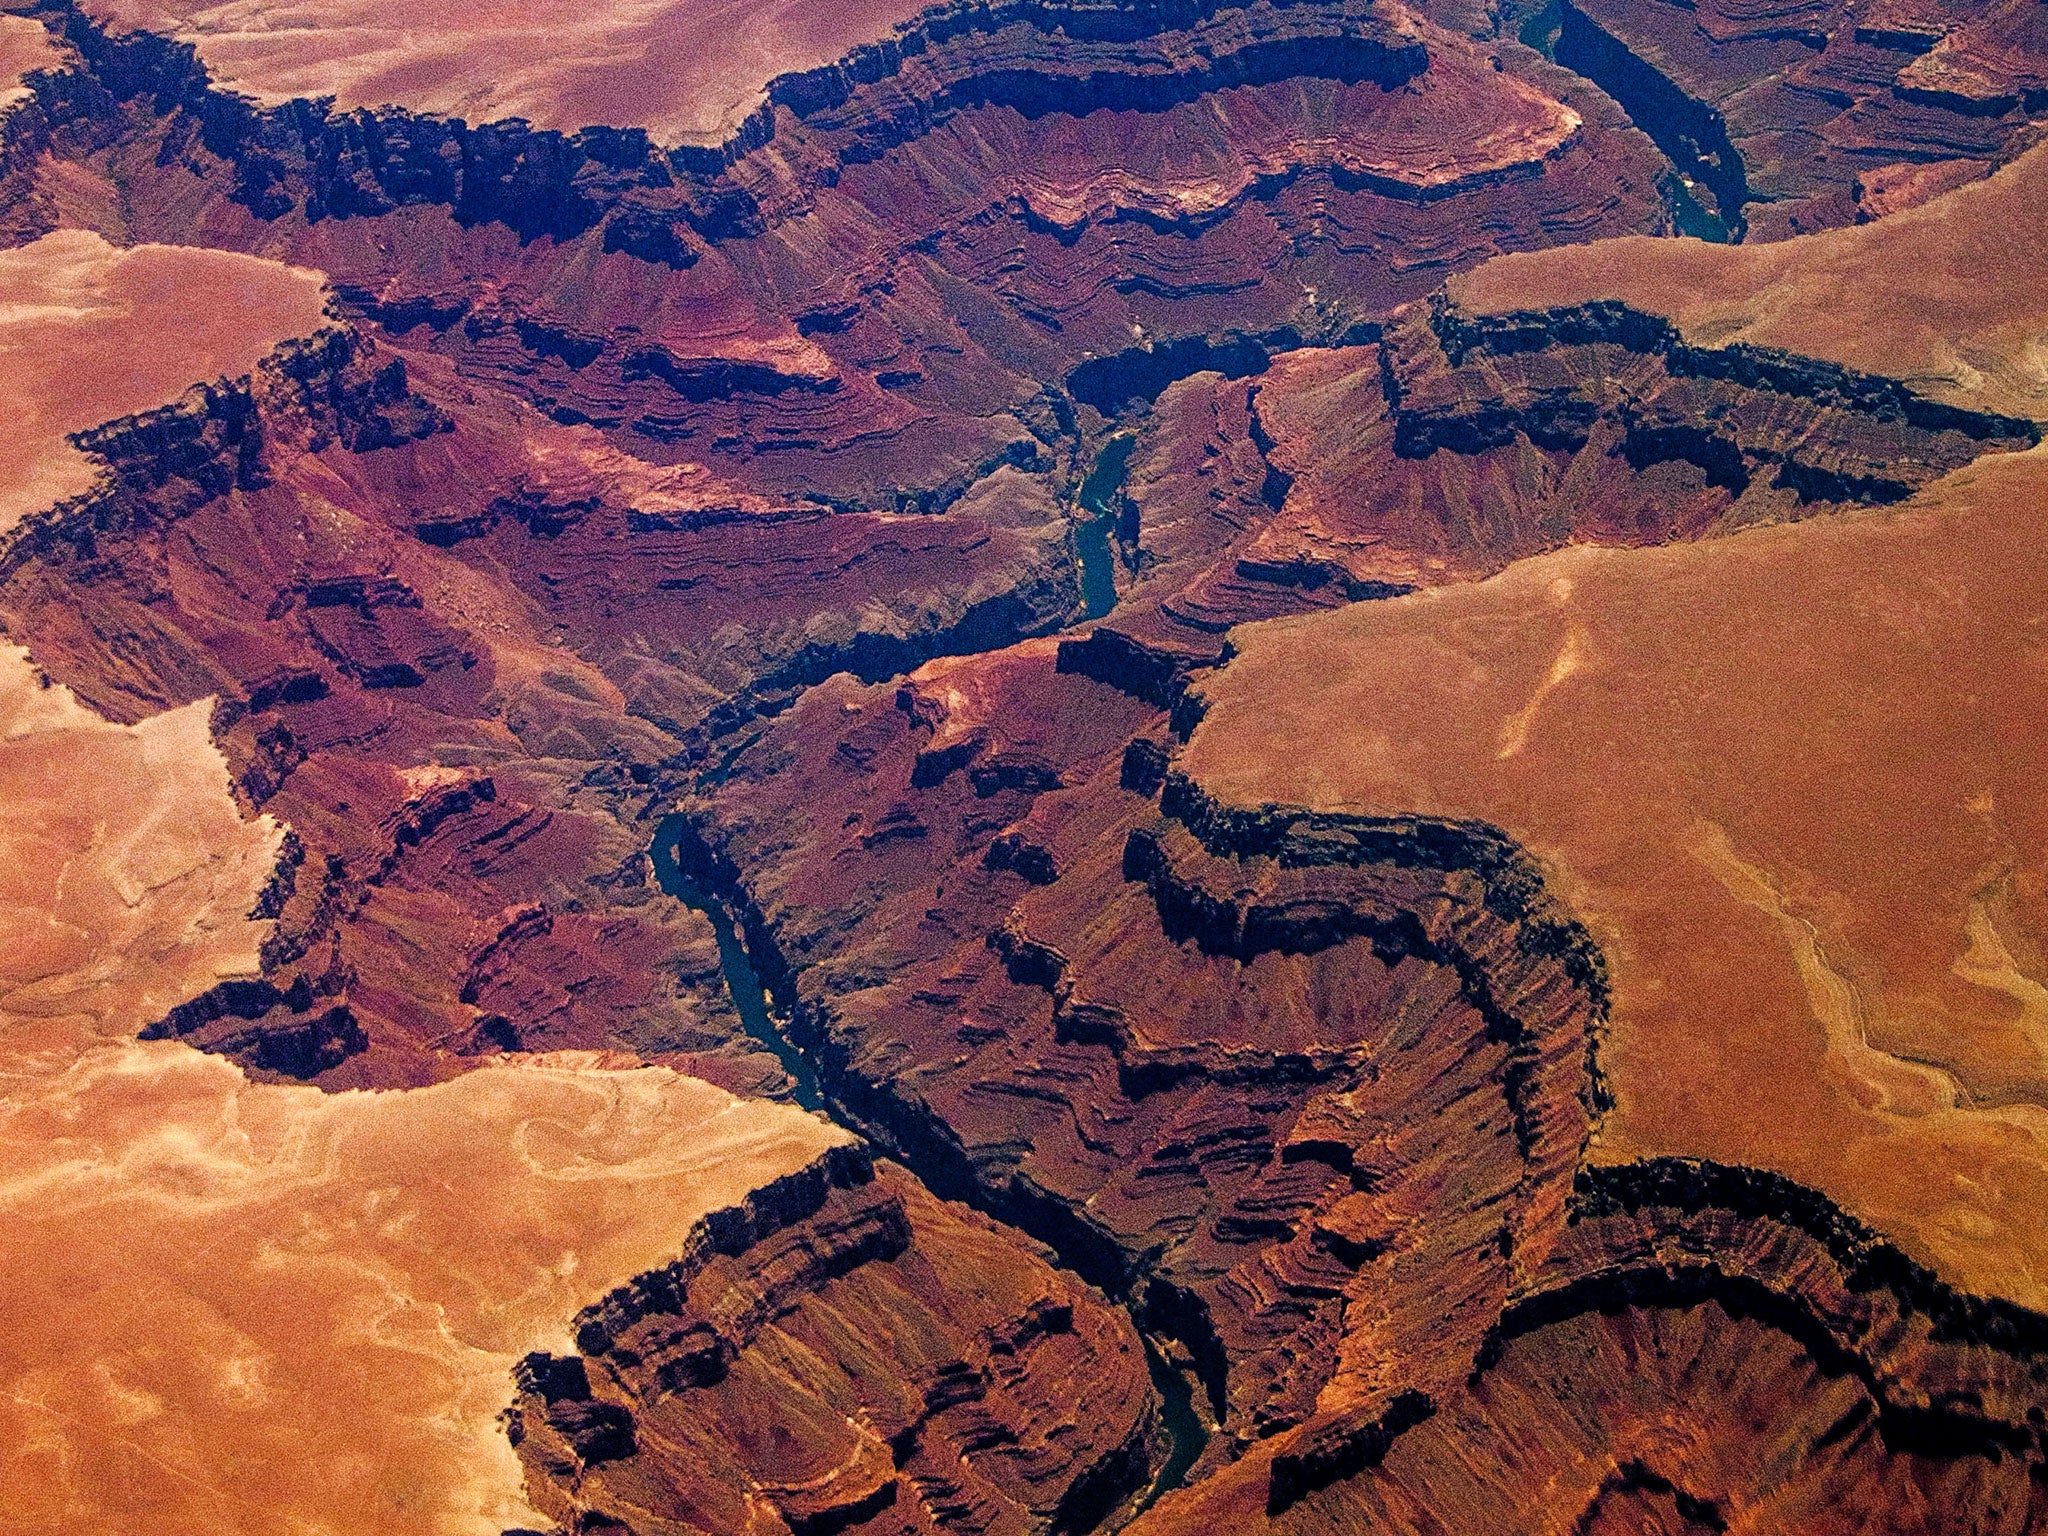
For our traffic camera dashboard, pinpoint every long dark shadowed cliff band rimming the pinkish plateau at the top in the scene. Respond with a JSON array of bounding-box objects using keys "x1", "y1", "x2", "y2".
[{"x1": 45, "y1": 0, "x2": 1523, "y2": 240}]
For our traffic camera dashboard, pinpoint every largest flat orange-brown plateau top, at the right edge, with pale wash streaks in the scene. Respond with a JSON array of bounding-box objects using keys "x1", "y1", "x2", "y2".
[{"x1": 1190, "y1": 451, "x2": 2042, "y2": 1300}]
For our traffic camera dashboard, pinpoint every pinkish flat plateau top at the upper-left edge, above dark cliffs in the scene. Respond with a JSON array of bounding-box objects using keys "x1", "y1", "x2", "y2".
[{"x1": 86, "y1": 0, "x2": 924, "y2": 143}]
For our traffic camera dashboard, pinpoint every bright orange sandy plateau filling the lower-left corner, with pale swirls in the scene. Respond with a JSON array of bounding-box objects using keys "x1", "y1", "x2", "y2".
[{"x1": 0, "y1": 647, "x2": 848, "y2": 1536}]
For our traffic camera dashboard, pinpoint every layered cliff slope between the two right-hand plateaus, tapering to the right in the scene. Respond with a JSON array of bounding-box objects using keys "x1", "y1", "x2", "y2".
[{"x1": 1063, "y1": 278, "x2": 2040, "y2": 705}]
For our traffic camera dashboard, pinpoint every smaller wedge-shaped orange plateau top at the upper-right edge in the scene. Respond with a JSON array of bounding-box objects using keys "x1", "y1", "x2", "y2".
[{"x1": 1446, "y1": 147, "x2": 2048, "y2": 418}]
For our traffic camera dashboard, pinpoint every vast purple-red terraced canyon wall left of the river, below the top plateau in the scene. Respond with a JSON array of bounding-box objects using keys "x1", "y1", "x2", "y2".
[{"x1": 6, "y1": 4, "x2": 1679, "y2": 1085}]
